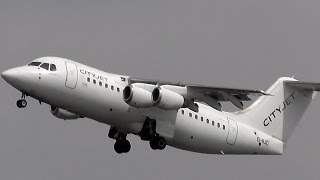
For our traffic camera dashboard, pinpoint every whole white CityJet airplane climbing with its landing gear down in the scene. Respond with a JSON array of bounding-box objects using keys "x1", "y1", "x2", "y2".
[{"x1": 1, "y1": 57, "x2": 320, "y2": 155}]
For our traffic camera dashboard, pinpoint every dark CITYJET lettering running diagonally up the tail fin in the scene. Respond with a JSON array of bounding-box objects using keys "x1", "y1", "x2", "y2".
[{"x1": 263, "y1": 92, "x2": 295, "y2": 126}]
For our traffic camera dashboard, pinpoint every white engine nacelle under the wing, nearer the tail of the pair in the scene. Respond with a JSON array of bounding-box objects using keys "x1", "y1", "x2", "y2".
[{"x1": 152, "y1": 87, "x2": 185, "y2": 110}]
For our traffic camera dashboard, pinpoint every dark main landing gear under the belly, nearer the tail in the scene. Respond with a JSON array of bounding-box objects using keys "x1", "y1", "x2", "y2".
[{"x1": 140, "y1": 118, "x2": 167, "y2": 150}]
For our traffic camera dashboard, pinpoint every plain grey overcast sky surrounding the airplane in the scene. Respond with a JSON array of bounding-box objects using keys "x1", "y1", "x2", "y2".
[{"x1": 0, "y1": 0, "x2": 320, "y2": 180}]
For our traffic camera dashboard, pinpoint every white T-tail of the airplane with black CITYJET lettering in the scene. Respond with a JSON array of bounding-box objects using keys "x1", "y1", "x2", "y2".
[{"x1": 236, "y1": 77, "x2": 320, "y2": 146}]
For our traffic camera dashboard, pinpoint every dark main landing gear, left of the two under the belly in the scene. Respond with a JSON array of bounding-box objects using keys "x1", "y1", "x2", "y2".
[{"x1": 108, "y1": 127, "x2": 131, "y2": 154}]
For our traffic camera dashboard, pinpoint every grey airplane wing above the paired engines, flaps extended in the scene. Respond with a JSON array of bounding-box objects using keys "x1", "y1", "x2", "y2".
[{"x1": 129, "y1": 78, "x2": 268, "y2": 111}]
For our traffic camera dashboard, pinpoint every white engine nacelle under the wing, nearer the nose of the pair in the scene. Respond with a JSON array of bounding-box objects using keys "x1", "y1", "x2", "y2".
[{"x1": 123, "y1": 84, "x2": 153, "y2": 108}]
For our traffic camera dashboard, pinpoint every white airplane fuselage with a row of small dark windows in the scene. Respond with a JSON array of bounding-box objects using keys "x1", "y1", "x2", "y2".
[{"x1": 3, "y1": 57, "x2": 283, "y2": 154}]
